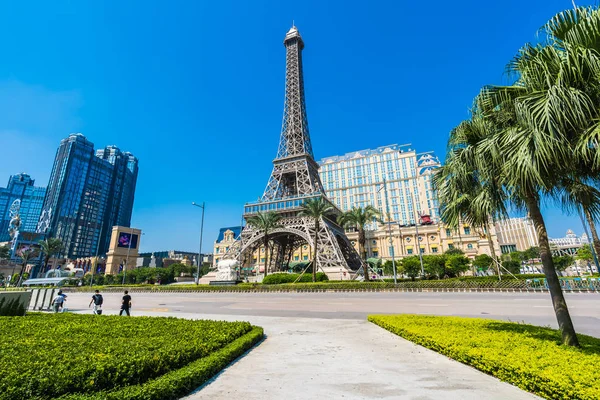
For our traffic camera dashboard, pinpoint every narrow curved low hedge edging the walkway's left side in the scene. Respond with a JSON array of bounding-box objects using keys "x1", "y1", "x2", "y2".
[{"x1": 60, "y1": 326, "x2": 264, "y2": 400}]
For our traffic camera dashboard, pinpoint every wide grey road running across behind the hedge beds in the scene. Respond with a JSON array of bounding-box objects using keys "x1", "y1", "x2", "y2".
[{"x1": 67, "y1": 292, "x2": 600, "y2": 337}]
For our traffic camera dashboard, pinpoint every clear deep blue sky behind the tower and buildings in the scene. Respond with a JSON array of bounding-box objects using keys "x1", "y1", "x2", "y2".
[{"x1": 0, "y1": 0, "x2": 588, "y2": 251}]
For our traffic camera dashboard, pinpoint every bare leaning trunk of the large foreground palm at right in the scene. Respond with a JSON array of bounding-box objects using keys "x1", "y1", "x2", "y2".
[{"x1": 525, "y1": 195, "x2": 579, "y2": 347}]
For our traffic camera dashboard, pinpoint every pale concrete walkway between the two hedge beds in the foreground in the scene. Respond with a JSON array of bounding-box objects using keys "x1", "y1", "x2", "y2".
[{"x1": 178, "y1": 315, "x2": 538, "y2": 400}]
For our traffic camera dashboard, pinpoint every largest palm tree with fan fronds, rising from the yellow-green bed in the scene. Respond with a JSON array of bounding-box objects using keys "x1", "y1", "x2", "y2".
[{"x1": 436, "y1": 3, "x2": 600, "y2": 346}]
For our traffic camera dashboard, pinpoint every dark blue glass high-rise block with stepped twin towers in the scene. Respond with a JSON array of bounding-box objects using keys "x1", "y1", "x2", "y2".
[{"x1": 38, "y1": 133, "x2": 138, "y2": 259}]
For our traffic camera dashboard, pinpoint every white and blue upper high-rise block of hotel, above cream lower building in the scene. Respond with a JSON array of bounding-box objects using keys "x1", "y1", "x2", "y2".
[{"x1": 319, "y1": 145, "x2": 440, "y2": 225}]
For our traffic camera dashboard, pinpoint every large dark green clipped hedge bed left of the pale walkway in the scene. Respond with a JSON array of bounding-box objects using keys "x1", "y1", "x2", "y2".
[{"x1": 0, "y1": 314, "x2": 263, "y2": 399}]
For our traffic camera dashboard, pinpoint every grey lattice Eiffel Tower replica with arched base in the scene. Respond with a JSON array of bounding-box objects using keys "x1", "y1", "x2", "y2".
[{"x1": 210, "y1": 26, "x2": 363, "y2": 279}]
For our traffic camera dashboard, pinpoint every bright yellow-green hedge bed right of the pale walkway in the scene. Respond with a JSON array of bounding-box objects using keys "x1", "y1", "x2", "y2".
[{"x1": 368, "y1": 315, "x2": 600, "y2": 400}]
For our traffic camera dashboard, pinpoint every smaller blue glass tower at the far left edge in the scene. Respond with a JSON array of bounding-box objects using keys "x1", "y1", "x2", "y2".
[{"x1": 0, "y1": 173, "x2": 46, "y2": 242}]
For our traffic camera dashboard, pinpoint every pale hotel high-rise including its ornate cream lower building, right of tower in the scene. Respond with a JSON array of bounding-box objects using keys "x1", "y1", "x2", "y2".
[{"x1": 319, "y1": 144, "x2": 500, "y2": 259}]
